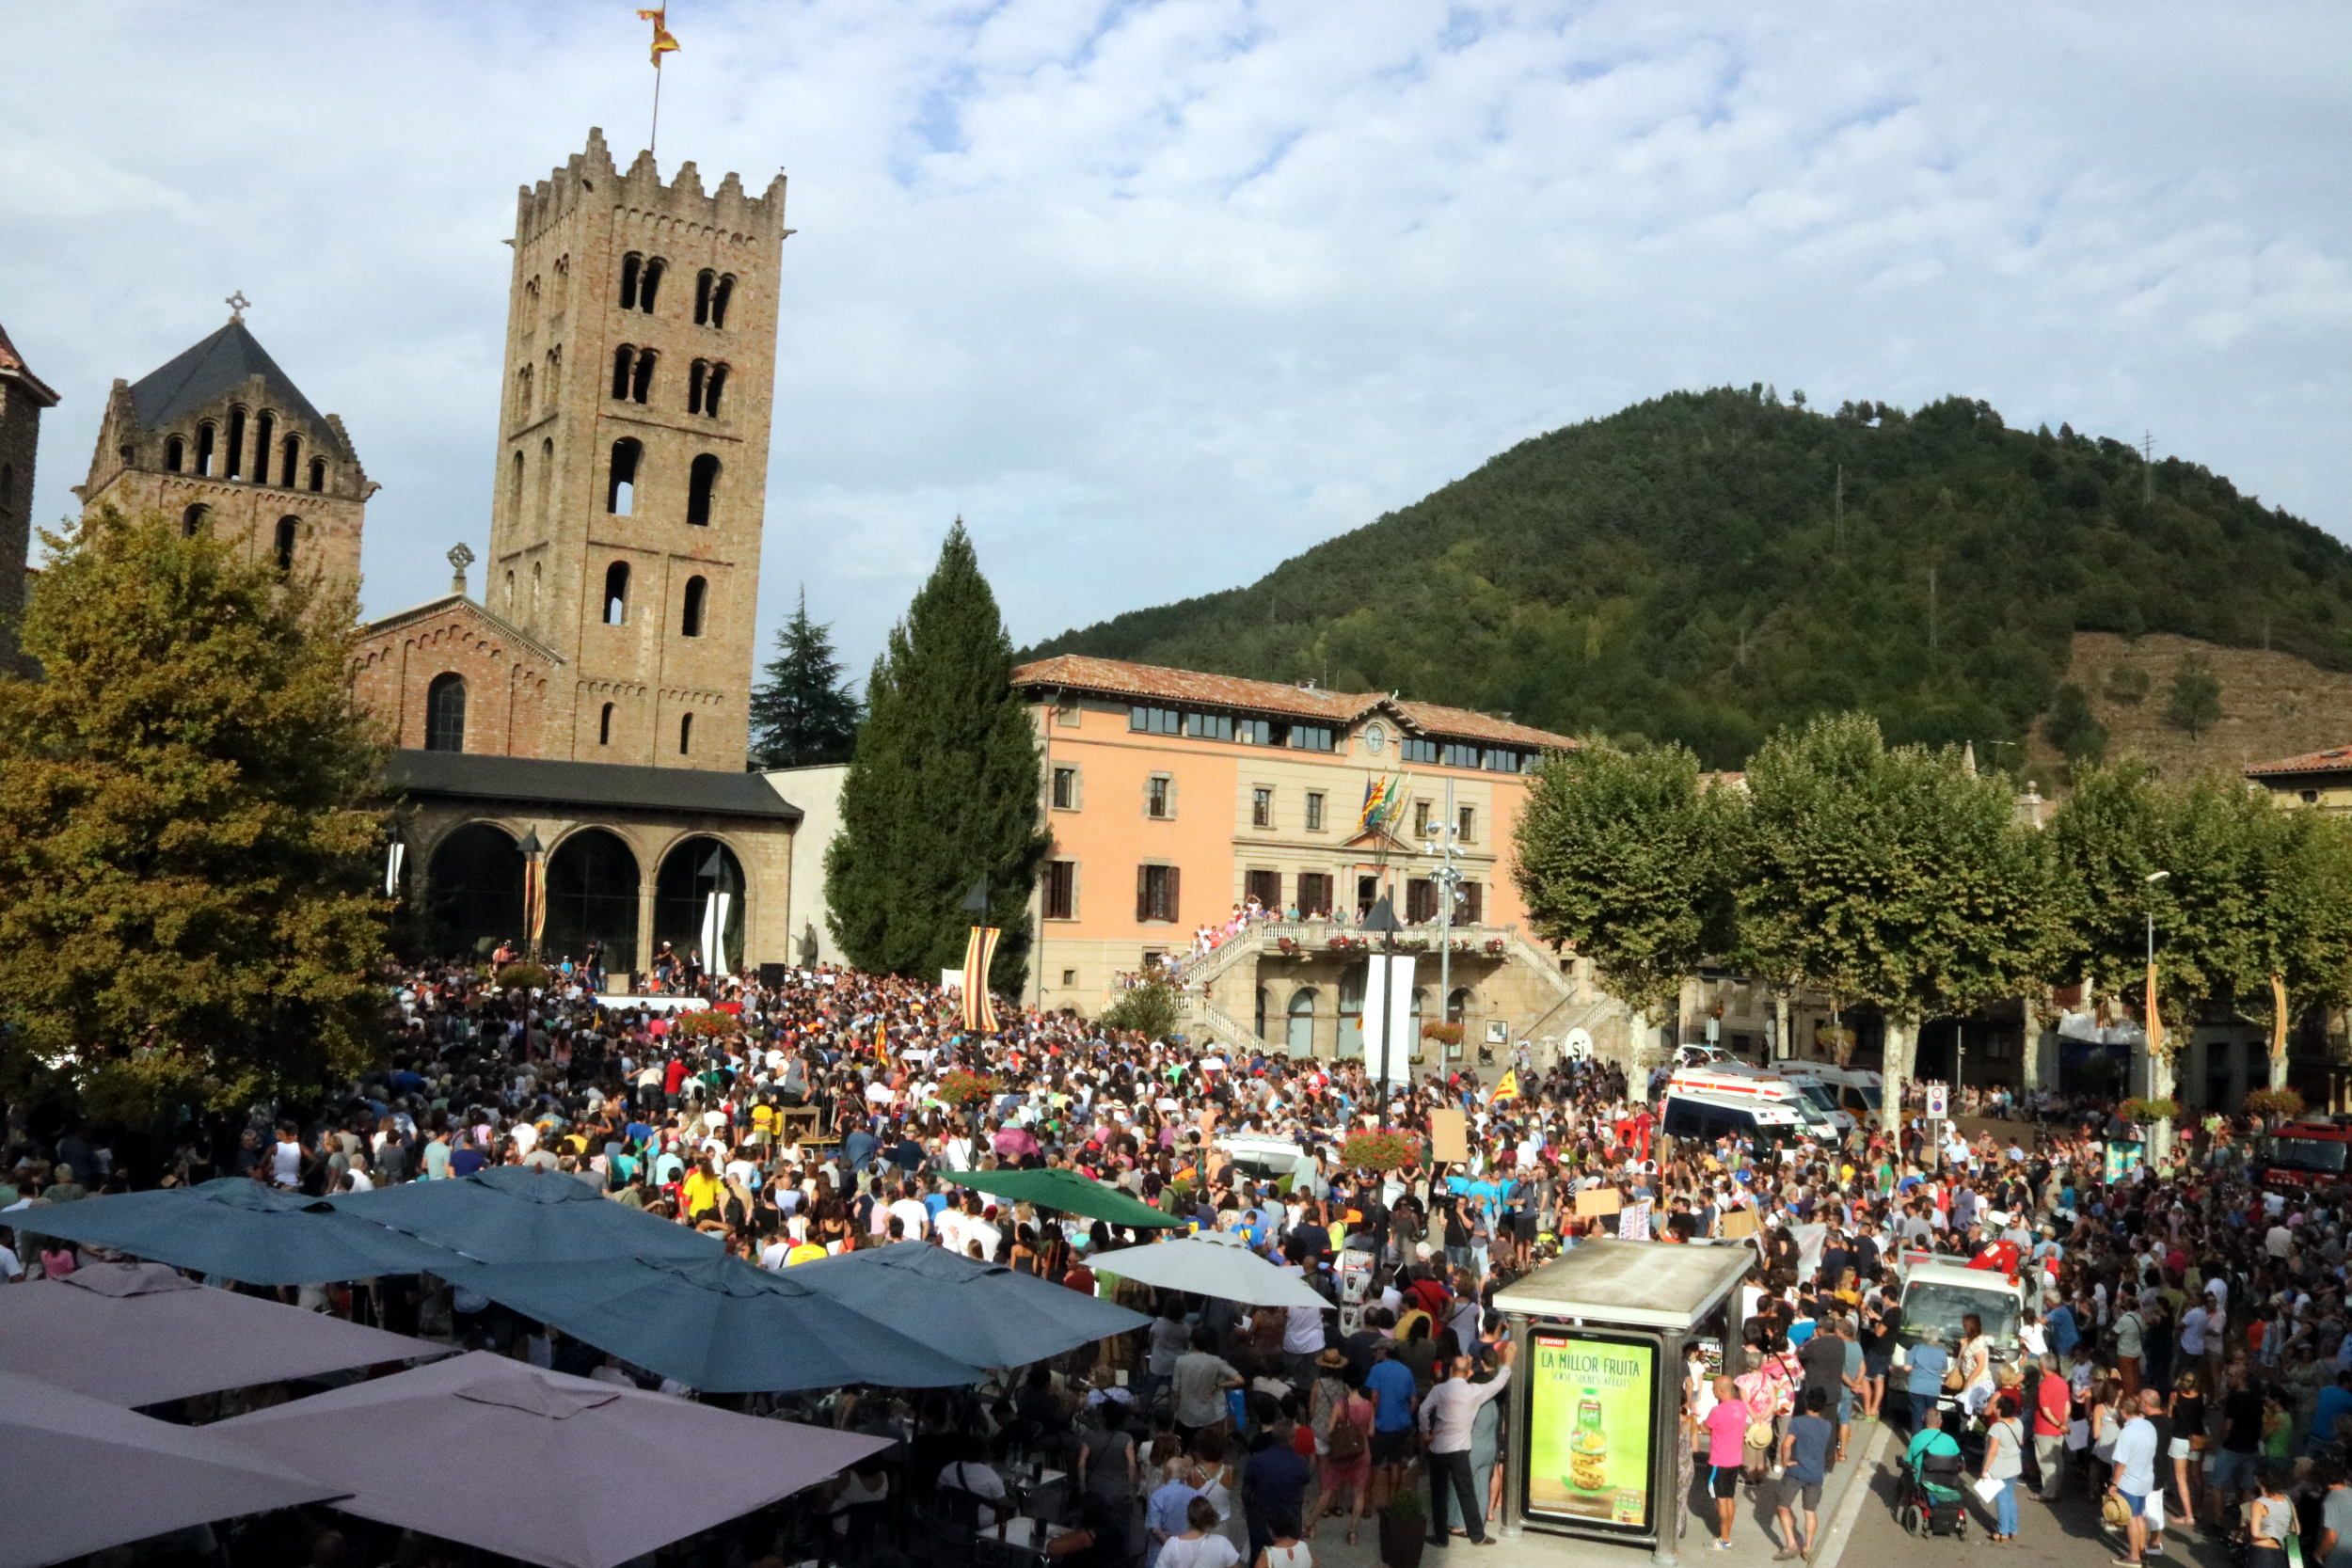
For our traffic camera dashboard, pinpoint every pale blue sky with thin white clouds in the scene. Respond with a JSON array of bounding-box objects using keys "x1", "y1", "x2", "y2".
[{"x1": 0, "y1": 0, "x2": 2352, "y2": 670}]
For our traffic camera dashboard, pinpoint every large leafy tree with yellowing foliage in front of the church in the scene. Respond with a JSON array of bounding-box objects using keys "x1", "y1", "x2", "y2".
[{"x1": 0, "y1": 510, "x2": 386, "y2": 1126}]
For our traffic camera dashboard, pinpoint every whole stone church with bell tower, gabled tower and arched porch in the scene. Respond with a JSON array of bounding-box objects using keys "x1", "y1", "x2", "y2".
[{"x1": 13, "y1": 132, "x2": 800, "y2": 985}]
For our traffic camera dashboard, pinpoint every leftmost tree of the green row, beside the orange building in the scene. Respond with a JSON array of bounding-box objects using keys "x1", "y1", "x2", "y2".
[{"x1": 1515, "y1": 738, "x2": 1736, "y2": 1049}]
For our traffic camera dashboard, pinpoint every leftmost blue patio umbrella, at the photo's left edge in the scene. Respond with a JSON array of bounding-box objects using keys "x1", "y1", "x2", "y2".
[{"x1": 17, "y1": 1176, "x2": 450, "y2": 1286}]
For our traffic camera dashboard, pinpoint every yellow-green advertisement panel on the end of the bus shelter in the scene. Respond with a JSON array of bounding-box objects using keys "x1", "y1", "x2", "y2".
[{"x1": 1527, "y1": 1326, "x2": 1659, "y2": 1535}]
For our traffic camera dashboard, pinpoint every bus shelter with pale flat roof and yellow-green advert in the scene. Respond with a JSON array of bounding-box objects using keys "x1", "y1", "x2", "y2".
[{"x1": 1494, "y1": 1242, "x2": 1757, "y2": 1563}]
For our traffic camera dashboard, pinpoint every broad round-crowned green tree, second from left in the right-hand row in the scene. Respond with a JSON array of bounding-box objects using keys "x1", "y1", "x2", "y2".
[{"x1": 1739, "y1": 715, "x2": 2060, "y2": 1115}]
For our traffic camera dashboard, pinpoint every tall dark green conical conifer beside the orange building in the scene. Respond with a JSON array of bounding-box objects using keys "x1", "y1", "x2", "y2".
[{"x1": 826, "y1": 517, "x2": 1047, "y2": 994}]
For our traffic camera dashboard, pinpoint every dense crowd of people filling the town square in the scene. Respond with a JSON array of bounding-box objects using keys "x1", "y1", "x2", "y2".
[{"x1": 0, "y1": 944, "x2": 2352, "y2": 1568}]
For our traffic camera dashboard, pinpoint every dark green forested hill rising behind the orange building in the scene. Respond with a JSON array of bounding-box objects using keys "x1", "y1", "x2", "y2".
[{"x1": 1033, "y1": 388, "x2": 2352, "y2": 767}]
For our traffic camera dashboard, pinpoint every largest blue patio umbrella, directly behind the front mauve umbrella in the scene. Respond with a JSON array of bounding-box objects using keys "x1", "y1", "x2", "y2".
[{"x1": 433, "y1": 1258, "x2": 978, "y2": 1394}]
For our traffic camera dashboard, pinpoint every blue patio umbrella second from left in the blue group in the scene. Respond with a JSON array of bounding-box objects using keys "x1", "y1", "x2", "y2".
[{"x1": 334, "y1": 1166, "x2": 723, "y2": 1275}]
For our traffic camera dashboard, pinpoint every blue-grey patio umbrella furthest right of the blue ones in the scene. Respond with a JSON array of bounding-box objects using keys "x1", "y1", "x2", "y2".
[{"x1": 786, "y1": 1242, "x2": 1151, "y2": 1366}]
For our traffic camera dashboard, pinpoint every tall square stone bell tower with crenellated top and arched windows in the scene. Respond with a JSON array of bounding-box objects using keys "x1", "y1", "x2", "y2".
[{"x1": 483, "y1": 129, "x2": 793, "y2": 771}]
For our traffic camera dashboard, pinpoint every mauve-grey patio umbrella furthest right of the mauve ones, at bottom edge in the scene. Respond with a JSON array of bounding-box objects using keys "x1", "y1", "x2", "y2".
[{"x1": 207, "y1": 1352, "x2": 889, "y2": 1568}]
